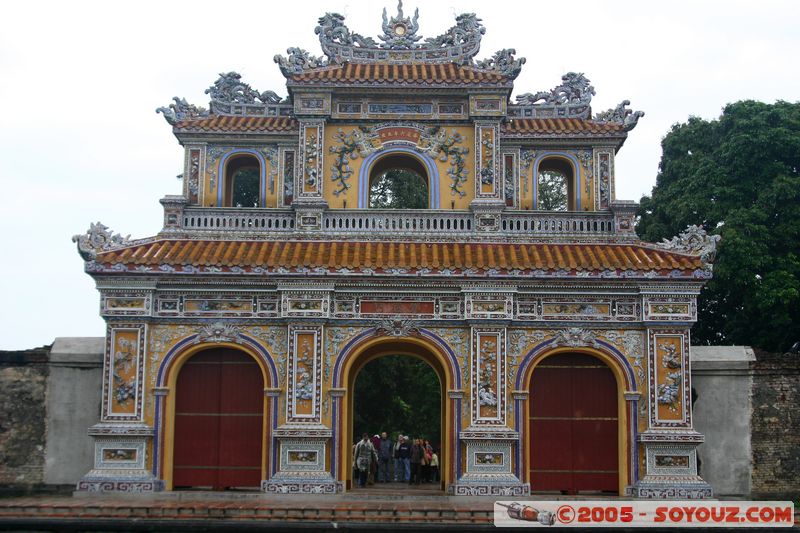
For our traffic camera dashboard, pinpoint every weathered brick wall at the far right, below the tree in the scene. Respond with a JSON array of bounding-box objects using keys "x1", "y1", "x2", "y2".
[{"x1": 751, "y1": 352, "x2": 800, "y2": 499}]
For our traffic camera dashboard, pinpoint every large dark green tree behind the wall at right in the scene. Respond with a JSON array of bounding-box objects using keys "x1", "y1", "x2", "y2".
[{"x1": 637, "y1": 101, "x2": 800, "y2": 351}]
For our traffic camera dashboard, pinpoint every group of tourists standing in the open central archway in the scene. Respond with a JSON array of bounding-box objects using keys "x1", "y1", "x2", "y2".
[{"x1": 353, "y1": 431, "x2": 439, "y2": 487}]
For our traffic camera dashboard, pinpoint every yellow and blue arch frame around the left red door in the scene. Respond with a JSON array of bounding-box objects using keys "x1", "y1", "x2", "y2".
[{"x1": 153, "y1": 334, "x2": 279, "y2": 490}]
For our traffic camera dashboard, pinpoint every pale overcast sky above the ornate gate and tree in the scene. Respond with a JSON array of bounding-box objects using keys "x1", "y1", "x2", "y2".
[{"x1": 0, "y1": 0, "x2": 800, "y2": 350}]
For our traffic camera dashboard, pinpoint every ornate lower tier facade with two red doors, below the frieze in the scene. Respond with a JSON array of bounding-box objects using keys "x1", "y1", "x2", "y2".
[{"x1": 78, "y1": 314, "x2": 712, "y2": 498}]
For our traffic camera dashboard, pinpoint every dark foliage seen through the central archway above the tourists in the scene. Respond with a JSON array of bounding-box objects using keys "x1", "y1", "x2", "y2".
[{"x1": 353, "y1": 355, "x2": 442, "y2": 446}]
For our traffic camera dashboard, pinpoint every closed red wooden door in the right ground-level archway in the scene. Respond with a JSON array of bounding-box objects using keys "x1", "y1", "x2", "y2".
[{"x1": 530, "y1": 354, "x2": 619, "y2": 493}]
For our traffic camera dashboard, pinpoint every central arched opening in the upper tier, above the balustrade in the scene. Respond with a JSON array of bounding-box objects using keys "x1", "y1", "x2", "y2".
[{"x1": 368, "y1": 153, "x2": 430, "y2": 209}]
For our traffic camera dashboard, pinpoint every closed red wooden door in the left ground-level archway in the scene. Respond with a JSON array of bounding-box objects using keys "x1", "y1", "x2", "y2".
[{"x1": 172, "y1": 348, "x2": 264, "y2": 490}]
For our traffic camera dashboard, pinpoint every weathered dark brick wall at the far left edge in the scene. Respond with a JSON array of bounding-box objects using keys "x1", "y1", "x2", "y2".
[{"x1": 0, "y1": 347, "x2": 49, "y2": 488}]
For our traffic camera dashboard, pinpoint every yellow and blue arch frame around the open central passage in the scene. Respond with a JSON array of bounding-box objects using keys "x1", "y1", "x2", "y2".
[{"x1": 337, "y1": 337, "x2": 457, "y2": 489}]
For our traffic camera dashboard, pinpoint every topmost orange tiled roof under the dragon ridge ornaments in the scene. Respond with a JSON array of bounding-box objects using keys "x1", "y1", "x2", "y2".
[{"x1": 289, "y1": 63, "x2": 511, "y2": 85}]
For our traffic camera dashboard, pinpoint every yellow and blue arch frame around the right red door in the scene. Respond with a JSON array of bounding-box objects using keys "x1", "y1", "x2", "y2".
[{"x1": 513, "y1": 339, "x2": 641, "y2": 496}]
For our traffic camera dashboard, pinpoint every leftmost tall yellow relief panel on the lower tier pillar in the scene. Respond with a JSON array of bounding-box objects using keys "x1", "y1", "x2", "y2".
[{"x1": 102, "y1": 324, "x2": 145, "y2": 421}]
